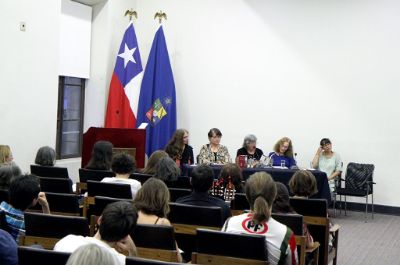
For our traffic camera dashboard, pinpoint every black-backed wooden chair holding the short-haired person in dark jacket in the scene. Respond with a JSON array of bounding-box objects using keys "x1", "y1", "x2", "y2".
[{"x1": 168, "y1": 203, "x2": 223, "y2": 260}]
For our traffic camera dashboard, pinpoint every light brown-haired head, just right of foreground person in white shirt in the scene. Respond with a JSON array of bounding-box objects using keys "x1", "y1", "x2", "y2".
[{"x1": 133, "y1": 178, "x2": 170, "y2": 218}]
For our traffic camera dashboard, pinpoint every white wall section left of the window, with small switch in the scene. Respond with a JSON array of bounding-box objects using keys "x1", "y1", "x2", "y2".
[{"x1": 0, "y1": 0, "x2": 61, "y2": 171}]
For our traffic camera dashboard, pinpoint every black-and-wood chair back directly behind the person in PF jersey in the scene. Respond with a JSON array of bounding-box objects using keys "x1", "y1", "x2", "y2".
[{"x1": 192, "y1": 229, "x2": 268, "y2": 265}]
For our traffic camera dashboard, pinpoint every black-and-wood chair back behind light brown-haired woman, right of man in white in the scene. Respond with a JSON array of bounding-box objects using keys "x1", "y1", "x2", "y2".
[{"x1": 131, "y1": 225, "x2": 178, "y2": 262}]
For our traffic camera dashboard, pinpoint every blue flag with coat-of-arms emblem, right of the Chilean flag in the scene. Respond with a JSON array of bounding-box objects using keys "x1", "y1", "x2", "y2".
[{"x1": 136, "y1": 26, "x2": 176, "y2": 156}]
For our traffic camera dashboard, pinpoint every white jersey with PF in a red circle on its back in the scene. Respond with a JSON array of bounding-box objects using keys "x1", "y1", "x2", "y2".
[{"x1": 222, "y1": 213, "x2": 298, "y2": 265}]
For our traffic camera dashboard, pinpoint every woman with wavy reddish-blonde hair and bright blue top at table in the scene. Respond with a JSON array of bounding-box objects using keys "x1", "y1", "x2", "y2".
[{"x1": 268, "y1": 137, "x2": 296, "y2": 168}]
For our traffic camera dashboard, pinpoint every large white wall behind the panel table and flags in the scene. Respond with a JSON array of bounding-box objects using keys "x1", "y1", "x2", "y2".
[{"x1": 87, "y1": 0, "x2": 400, "y2": 205}]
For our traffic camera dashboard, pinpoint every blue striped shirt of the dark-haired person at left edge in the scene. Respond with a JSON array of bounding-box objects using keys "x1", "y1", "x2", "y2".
[{"x1": 0, "y1": 201, "x2": 25, "y2": 243}]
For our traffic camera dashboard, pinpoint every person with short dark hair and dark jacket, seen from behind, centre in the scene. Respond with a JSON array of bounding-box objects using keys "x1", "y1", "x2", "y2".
[{"x1": 176, "y1": 165, "x2": 231, "y2": 222}]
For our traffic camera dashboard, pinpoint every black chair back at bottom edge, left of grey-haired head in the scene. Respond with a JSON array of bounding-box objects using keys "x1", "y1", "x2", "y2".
[{"x1": 18, "y1": 246, "x2": 71, "y2": 265}]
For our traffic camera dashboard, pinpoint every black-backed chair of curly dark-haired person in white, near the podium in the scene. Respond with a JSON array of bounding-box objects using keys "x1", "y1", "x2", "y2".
[{"x1": 83, "y1": 180, "x2": 132, "y2": 217}]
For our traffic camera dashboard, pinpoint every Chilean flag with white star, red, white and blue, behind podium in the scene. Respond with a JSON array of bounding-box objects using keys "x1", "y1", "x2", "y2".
[{"x1": 105, "y1": 22, "x2": 143, "y2": 128}]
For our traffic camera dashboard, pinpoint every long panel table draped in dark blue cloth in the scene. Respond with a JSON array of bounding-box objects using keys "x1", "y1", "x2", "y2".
[{"x1": 181, "y1": 165, "x2": 331, "y2": 205}]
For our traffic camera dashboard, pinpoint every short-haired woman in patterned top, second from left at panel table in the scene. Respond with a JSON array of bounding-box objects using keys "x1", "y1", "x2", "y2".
[{"x1": 199, "y1": 128, "x2": 231, "y2": 165}]
